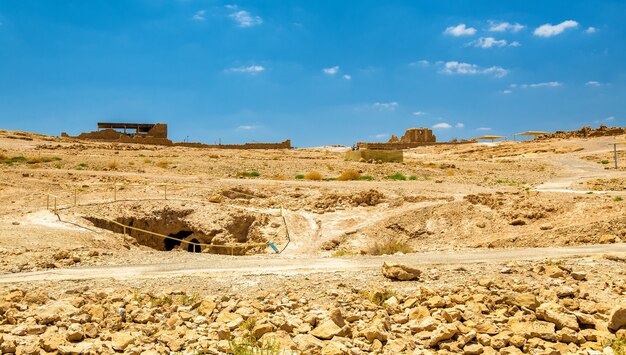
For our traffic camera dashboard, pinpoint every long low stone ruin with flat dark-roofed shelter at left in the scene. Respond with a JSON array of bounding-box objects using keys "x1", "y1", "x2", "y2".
[{"x1": 61, "y1": 122, "x2": 291, "y2": 149}]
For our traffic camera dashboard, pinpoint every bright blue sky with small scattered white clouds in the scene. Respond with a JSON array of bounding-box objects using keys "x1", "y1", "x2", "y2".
[{"x1": 0, "y1": 0, "x2": 626, "y2": 147}]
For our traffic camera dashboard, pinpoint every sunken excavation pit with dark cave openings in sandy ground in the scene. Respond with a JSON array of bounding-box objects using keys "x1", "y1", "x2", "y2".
[{"x1": 84, "y1": 203, "x2": 270, "y2": 255}]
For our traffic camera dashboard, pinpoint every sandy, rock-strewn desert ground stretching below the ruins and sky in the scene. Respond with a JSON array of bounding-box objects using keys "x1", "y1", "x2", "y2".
[{"x1": 0, "y1": 131, "x2": 626, "y2": 354}]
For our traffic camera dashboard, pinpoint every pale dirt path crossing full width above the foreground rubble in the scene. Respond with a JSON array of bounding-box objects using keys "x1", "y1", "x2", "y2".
[{"x1": 0, "y1": 243, "x2": 626, "y2": 284}]
